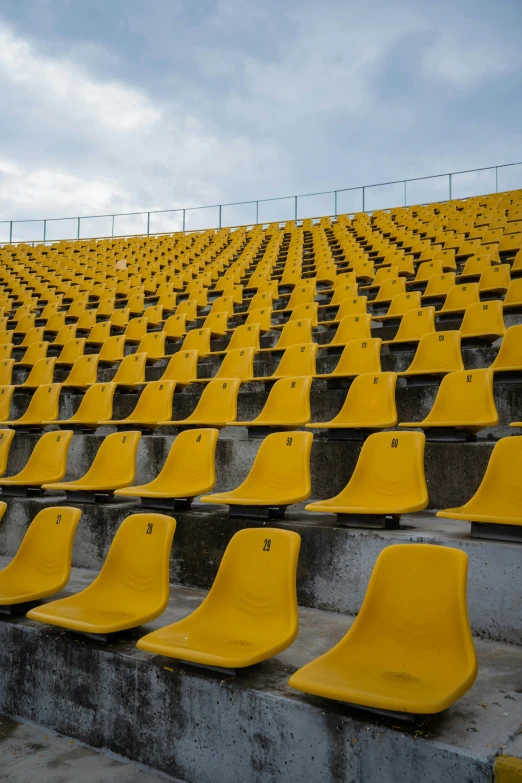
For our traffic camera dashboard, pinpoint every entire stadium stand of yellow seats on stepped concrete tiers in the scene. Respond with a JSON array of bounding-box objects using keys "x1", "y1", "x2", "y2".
[{"x1": 0, "y1": 191, "x2": 522, "y2": 783}]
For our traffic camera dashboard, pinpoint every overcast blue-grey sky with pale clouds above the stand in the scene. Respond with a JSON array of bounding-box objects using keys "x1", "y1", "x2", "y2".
[{"x1": 0, "y1": 0, "x2": 522, "y2": 241}]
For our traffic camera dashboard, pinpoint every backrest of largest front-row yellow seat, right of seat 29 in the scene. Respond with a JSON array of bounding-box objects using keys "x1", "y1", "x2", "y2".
[{"x1": 346, "y1": 544, "x2": 477, "y2": 679}]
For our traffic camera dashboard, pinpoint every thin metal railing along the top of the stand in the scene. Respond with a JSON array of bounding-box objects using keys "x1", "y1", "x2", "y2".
[{"x1": 0, "y1": 162, "x2": 522, "y2": 244}]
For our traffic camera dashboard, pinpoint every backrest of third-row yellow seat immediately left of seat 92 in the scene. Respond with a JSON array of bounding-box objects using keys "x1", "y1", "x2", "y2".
[{"x1": 334, "y1": 372, "x2": 397, "y2": 428}]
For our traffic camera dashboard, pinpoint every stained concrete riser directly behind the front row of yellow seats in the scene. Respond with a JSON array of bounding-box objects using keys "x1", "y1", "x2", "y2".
[{"x1": 0, "y1": 506, "x2": 522, "y2": 645}]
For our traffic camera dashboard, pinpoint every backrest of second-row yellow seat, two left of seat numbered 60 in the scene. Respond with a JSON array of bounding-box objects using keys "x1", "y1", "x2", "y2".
[{"x1": 158, "y1": 427, "x2": 219, "y2": 497}]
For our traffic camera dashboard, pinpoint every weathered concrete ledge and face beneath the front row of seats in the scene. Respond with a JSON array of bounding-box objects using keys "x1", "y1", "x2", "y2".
[{"x1": 0, "y1": 572, "x2": 522, "y2": 783}]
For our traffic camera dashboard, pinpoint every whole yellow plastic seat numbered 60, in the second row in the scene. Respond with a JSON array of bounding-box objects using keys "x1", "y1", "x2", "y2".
[{"x1": 305, "y1": 432, "x2": 428, "y2": 529}]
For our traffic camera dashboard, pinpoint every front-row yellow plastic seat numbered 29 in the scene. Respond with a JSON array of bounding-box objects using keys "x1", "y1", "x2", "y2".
[{"x1": 137, "y1": 528, "x2": 301, "y2": 670}]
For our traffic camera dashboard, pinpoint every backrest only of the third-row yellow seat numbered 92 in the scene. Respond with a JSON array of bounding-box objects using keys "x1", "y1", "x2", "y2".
[{"x1": 425, "y1": 369, "x2": 498, "y2": 426}]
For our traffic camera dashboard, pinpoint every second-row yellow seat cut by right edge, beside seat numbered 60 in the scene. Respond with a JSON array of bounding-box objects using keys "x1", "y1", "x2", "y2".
[{"x1": 437, "y1": 438, "x2": 522, "y2": 542}]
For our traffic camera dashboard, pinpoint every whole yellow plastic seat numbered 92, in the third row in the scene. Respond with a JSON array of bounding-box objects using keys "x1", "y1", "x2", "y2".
[{"x1": 399, "y1": 369, "x2": 498, "y2": 440}]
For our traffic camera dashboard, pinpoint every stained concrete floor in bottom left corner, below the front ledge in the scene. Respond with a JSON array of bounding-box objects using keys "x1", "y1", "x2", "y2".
[{"x1": 0, "y1": 716, "x2": 177, "y2": 783}]
